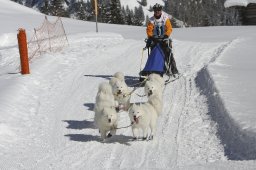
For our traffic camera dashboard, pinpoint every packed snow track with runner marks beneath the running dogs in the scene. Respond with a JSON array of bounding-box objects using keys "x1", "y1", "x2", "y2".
[{"x1": 0, "y1": 34, "x2": 232, "y2": 169}]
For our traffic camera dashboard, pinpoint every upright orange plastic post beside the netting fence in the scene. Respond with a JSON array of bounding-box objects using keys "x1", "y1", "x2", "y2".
[{"x1": 17, "y1": 28, "x2": 29, "y2": 74}]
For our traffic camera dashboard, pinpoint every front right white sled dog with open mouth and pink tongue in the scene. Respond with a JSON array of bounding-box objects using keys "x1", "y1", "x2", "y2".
[{"x1": 129, "y1": 102, "x2": 157, "y2": 140}]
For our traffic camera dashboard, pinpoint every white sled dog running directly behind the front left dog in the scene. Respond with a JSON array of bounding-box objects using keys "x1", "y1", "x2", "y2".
[{"x1": 112, "y1": 79, "x2": 131, "y2": 111}]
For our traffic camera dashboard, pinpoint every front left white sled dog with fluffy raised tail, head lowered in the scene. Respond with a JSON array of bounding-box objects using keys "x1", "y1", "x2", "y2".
[{"x1": 94, "y1": 82, "x2": 118, "y2": 140}]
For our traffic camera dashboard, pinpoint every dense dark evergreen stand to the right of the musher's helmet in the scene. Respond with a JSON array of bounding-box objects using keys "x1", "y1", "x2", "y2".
[{"x1": 165, "y1": 0, "x2": 239, "y2": 26}]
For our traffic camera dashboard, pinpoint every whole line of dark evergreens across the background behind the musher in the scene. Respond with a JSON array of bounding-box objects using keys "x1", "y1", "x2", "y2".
[{"x1": 12, "y1": 0, "x2": 239, "y2": 26}]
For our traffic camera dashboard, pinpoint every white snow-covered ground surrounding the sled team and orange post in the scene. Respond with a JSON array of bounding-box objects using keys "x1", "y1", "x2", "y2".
[{"x1": 0, "y1": 0, "x2": 256, "y2": 170}]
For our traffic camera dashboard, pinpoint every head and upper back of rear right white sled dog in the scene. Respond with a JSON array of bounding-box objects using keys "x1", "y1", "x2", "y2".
[{"x1": 144, "y1": 81, "x2": 163, "y2": 99}]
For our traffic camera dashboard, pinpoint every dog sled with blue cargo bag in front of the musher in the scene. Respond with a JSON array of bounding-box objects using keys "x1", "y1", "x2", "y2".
[{"x1": 139, "y1": 36, "x2": 179, "y2": 82}]
